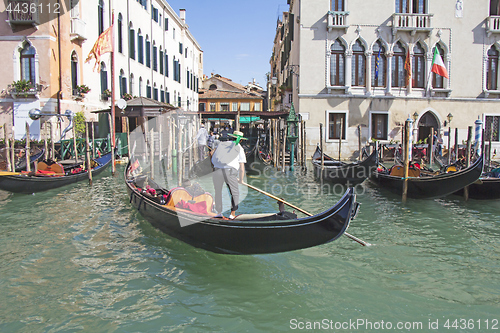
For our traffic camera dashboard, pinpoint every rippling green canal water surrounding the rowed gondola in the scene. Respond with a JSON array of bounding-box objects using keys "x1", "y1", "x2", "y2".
[{"x1": 0, "y1": 167, "x2": 500, "y2": 332}]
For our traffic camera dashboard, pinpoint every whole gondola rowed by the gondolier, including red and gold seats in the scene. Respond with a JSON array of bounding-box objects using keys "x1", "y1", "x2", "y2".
[{"x1": 125, "y1": 162, "x2": 358, "y2": 254}]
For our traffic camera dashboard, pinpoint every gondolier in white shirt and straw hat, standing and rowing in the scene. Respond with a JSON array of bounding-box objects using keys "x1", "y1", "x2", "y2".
[{"x1": 212, "y1": 131, "x2": 247, "y2": 219}]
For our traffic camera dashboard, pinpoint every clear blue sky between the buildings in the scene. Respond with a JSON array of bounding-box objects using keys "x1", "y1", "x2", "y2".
[{"x1": 167, "y1": 0, "x2": 288, "y2": 89}]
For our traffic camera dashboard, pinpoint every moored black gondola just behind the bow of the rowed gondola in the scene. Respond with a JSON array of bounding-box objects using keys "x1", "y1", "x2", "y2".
[{"x1": 312, "y1": 147, "x2": 378, "y2": 186}]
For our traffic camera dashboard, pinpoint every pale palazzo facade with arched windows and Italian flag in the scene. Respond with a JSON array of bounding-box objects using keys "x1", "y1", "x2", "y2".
[{"x1": 270, "y1": 0, "x2": 500, "y2": 158}]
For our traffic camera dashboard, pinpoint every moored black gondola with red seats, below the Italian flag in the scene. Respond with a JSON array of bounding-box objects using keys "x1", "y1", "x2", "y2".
[{"x1": 371, "y1": 156, "x2": 483, "y2": 199}]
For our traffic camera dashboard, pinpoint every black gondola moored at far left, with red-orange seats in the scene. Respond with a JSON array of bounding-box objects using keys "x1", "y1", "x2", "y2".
[{"x1": 0, "y1": 153, "x2": 111, "y2": 193}]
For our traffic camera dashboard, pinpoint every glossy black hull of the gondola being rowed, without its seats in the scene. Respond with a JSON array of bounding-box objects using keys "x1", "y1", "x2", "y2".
[{"x1": 127, "y1": 169, "x2": 357, "y2": 254}]
